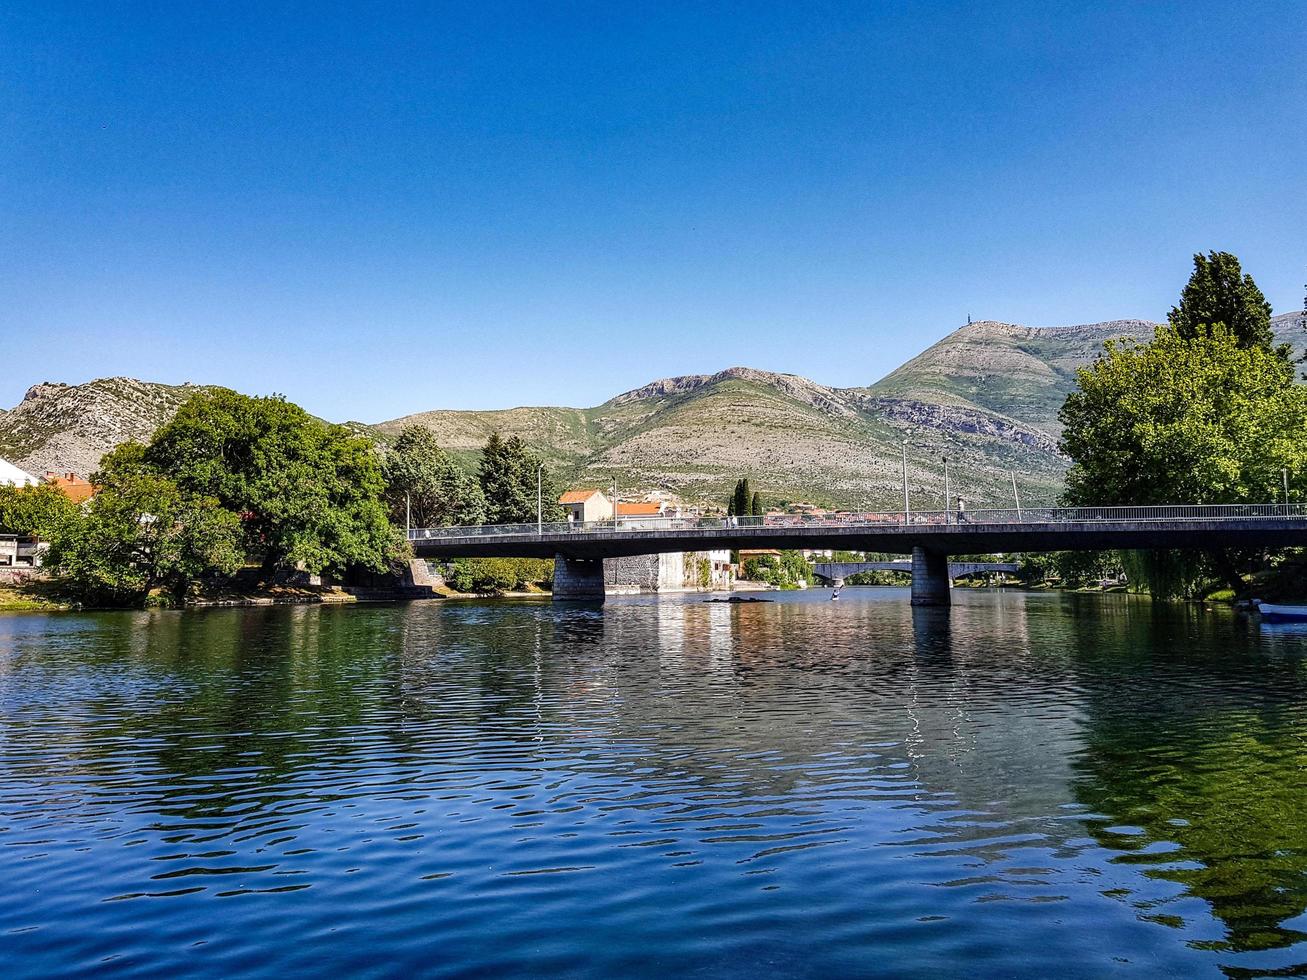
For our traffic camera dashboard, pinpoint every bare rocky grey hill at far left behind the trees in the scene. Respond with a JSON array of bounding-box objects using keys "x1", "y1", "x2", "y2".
[{"x1": 0, "y1": 378, "x2": 216, "y2": 476}]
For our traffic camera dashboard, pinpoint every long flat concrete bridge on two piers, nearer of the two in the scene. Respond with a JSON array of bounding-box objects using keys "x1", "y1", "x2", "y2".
[{"x1": 409, "y1": 503, "x2": 1307, "y2": 605}]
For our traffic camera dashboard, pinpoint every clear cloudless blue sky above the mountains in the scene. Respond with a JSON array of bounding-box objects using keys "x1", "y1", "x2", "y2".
[{"x1": 0, "y1": 0, "x2": 1307, "y2": 422}]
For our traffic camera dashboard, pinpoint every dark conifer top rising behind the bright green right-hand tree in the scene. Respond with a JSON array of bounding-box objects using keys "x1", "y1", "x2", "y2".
[{"x1": 1167, "y1": 252, "x2": 1274, "y2": 350}]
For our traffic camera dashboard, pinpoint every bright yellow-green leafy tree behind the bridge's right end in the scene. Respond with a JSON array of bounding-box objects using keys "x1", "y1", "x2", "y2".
[{"x1": 1059, "y1": 325, "x2": 1307, "y2": 596}]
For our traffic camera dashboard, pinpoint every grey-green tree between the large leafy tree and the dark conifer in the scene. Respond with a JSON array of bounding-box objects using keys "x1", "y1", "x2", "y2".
[{"x1": 382, "y1": 425, "x2": 485, "y2": 528}]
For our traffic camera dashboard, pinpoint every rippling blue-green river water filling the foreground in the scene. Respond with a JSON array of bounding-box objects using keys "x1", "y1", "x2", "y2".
[{"x1": 0, "y1": 589, "x2": 1307, "y2": 977}]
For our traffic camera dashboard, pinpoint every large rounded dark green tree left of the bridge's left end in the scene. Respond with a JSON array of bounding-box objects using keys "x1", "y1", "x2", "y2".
[{"x1": 141, "y1": 388, "x2": 403, "y2": 575}]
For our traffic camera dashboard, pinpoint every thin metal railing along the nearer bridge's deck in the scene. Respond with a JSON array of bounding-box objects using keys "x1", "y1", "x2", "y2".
[{"x1": 408, "y1": 503, "x2": 1307, "y2": 541}]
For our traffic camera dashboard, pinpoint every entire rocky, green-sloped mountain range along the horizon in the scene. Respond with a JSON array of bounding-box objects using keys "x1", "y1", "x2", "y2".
[{"x1": 0, "y1": 312, "x2": 1307, "y2": 510}]
